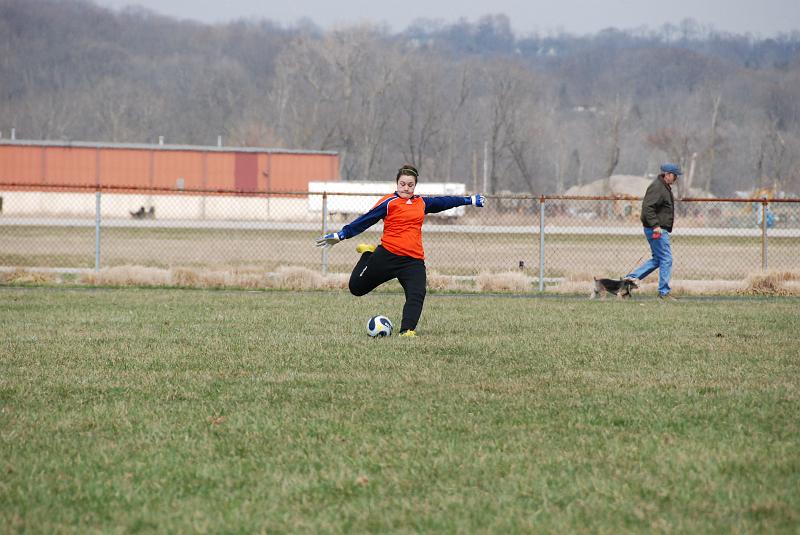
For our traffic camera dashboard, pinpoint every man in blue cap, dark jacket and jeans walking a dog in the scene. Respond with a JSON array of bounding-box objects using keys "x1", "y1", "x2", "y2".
[{"x1": 625, "y1": 163, "x2": 683, "y2": 300}]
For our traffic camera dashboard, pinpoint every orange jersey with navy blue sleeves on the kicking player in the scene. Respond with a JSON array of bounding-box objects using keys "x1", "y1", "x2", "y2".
[{"x1": 339, "y1": 192, "x2": 472, "y2": 260}]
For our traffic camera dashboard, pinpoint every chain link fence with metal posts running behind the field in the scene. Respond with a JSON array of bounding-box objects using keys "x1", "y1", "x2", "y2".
[{"x1": 0, "y1": 185, "x2": 800, "y2": 289}]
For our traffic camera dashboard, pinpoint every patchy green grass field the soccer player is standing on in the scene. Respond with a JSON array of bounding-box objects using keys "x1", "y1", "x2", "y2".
[{"x1": 0, "y1": 287, "x2": 800, "y2": 533}]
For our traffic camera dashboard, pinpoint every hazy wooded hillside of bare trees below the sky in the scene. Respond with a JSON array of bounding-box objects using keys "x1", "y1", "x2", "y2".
[{"x1": 0, "y1": 0, "x2": 800, "y2": 195}]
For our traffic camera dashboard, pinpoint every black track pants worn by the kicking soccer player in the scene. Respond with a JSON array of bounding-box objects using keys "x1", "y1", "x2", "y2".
[{"x1": 350, "y1": 245, "x2": 427, "y2": 332}]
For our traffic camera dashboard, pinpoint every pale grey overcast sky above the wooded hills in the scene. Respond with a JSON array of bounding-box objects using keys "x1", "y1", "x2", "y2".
[{"x1": 92, "y1": 0, "x2": 800, "y2": 37}]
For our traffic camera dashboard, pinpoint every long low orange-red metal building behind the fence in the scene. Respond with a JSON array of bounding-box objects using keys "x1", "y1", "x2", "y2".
[{"x1": 0, "y1": 140, "x2": 340, "y2": 192}]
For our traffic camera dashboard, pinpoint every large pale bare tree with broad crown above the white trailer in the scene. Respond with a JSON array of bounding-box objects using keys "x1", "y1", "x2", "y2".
[{"x1": 273, "y1": 26, "x2": 402, "y2": 179}]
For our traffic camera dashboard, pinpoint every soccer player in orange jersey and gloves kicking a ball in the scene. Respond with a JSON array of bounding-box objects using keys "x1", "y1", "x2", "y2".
[{"x1": 317, "y1": 165, "x2": 485, "y2": 336}]
